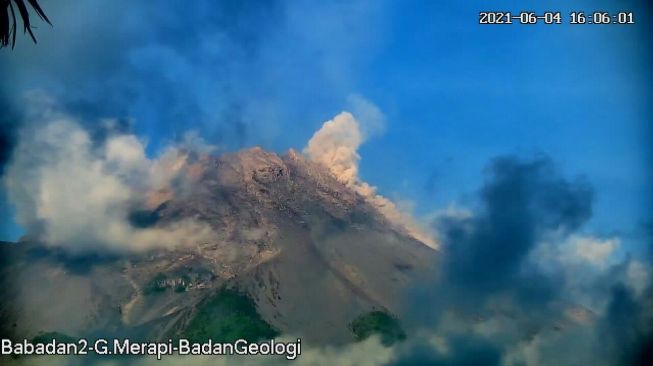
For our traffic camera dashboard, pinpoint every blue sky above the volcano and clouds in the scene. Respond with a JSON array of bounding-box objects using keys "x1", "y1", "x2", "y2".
[{"x1": 0, "y1": 0, "x2": 653, "y2": 258}]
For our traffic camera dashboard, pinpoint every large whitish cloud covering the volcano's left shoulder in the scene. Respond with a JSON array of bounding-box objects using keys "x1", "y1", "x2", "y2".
[{"x1": 4, "y1": 97, "x2": 211, "y2": 251}]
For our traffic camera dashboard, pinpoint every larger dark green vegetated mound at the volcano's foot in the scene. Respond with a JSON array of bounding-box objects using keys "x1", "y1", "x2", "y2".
[{"x1": 181, "y1": 288, "x2": 279, "y2": 342}]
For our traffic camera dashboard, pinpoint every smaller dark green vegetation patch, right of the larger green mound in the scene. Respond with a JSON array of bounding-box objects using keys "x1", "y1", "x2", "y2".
[{"x1": 349, "y1": 310, "x2": 406, "y2": 346}]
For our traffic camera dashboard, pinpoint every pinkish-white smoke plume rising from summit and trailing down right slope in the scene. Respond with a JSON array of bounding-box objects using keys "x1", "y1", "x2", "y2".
[{"x1": 304, "y1": 106, "x2": 438, "y2": 248}]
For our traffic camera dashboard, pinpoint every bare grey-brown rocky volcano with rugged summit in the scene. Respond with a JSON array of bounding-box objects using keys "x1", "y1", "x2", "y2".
[{"x1": 0, "y1": 148, "x2": 438, "y2": 344}]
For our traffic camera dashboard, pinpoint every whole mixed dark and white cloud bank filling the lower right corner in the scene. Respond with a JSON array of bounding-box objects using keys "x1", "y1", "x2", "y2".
[{"x1": 389, "y1": 156, "x2": 653, "y2": 365}]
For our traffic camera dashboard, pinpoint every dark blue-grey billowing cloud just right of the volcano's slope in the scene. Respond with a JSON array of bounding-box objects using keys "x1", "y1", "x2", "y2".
[{"x1": 437, "y1": 157, "x2": 593, "y2": 302}]
